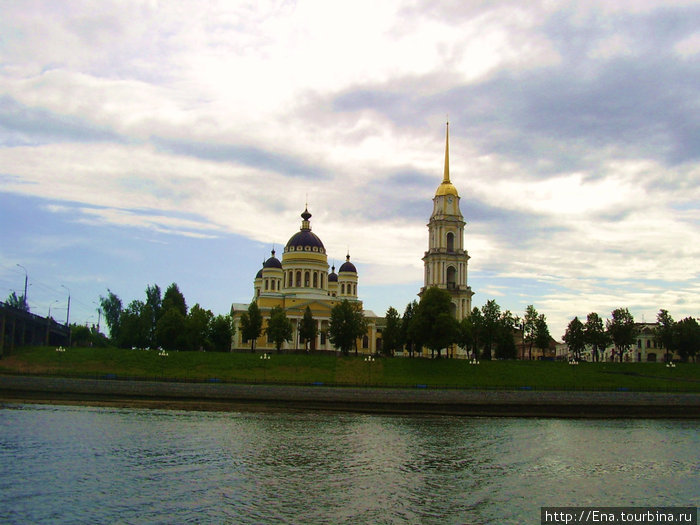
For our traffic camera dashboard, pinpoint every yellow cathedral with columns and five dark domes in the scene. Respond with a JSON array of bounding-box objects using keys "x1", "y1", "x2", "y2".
[{"x1": 233, "y1": 209, "x2": 377, "y2": 353}]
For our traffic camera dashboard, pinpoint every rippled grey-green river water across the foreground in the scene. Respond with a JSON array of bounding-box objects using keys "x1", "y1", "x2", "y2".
[{"x1": 0, "y1": 404, "x2": 700, "y2": 524}]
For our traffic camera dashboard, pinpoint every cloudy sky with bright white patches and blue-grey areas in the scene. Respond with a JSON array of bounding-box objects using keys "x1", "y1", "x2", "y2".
[{"x1": 0, "y1": 0, "x2": 700, "y2": 340}]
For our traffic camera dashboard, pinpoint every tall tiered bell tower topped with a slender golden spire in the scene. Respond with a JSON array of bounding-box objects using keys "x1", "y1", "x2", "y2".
[{"x1": 418, "y1": 122, "x2": 474, "y2": 320}]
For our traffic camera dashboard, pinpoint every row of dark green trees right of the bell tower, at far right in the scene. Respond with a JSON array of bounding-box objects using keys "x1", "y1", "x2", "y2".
[{"x1": 563, "y1": 308, "x2": 700, "y2": 362}]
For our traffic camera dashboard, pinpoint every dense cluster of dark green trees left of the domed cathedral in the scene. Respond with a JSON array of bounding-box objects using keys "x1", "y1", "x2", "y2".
[{"x1": 100, "y1": 283, "x2": 234, "y2": 352}]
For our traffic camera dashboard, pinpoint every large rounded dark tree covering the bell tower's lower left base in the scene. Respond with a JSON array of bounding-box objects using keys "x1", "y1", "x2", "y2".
[{"x1": 411, "y1": 287, "x2": 459, "y2": 358}]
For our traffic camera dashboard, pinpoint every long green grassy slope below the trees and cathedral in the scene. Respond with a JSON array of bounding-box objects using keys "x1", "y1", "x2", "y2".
[{"x1": 0, "y1": 347, "x2": 700, "y2": 392}]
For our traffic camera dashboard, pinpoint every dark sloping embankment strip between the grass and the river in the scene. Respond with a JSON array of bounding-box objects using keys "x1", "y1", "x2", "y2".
[{"x1": 0, "y1": 375, "x2": 700, "y2": 419}]
